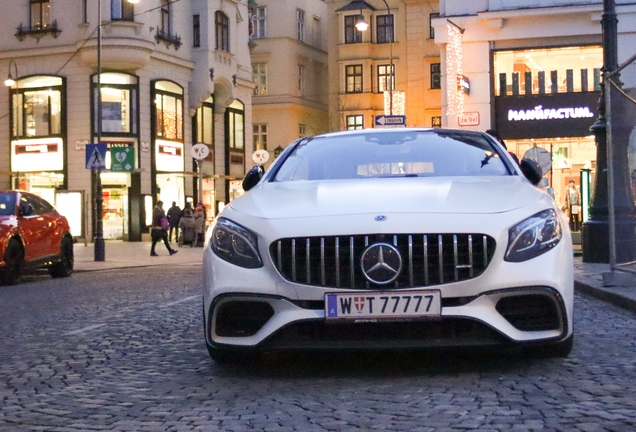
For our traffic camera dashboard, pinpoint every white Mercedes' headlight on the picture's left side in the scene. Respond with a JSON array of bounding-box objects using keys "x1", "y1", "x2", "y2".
[{"x1": 210, "y1": 218, "x2": 263, "y2": 268}]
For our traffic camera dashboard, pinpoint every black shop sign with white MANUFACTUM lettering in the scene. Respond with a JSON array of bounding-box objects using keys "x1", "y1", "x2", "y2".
[{"x1": 495, "y1": 92, "x2": 600, "y2": 139}]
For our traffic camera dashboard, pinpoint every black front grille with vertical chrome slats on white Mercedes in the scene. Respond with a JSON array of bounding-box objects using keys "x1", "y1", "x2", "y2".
[{"x1": 270, "y1": 234, "x2": 495, "y2": 289}]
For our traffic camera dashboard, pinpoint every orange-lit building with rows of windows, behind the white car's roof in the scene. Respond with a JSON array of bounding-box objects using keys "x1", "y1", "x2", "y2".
[{"x1": 327, "y1": 0, "x2": 442, "y2": 130}]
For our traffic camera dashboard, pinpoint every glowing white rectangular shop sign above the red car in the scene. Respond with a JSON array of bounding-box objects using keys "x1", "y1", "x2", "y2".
[{"x1": 11, "y1": 138, "x2": 64, "y2": 172}]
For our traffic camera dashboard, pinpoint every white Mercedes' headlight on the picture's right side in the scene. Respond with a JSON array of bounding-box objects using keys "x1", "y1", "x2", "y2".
[{"x1": 504, "y1": 209, "x2": 562, "y2": 262}]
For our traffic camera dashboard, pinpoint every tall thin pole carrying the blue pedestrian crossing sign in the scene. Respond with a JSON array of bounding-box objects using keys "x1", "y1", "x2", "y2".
[{"x1": 94, "y1": 0, "x2": 139, "y2": 261}]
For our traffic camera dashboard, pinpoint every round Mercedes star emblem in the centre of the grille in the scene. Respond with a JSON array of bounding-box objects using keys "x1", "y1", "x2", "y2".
[{"x1": 360, "y1": 243, "x2": 402, "y2": 285}]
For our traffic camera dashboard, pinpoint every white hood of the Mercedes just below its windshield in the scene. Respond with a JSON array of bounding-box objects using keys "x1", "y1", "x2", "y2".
[{"x1": 230, "y1": 176, "x2": 544, "y2": 219}]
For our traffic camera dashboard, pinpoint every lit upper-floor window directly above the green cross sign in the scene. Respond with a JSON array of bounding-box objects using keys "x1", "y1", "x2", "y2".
[{"x1": 92, "y1": 73, "x2": 139, "y2": 135}]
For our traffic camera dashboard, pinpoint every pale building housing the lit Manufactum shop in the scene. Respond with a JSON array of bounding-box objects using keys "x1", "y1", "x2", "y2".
[{"x1": 434, "y1": 0, "x2": 636, "y2": 231}]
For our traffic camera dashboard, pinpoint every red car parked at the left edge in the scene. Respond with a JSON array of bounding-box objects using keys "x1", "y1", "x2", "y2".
[{"x1": 0, "y1": 190, "x2": 74, "y2": 285}]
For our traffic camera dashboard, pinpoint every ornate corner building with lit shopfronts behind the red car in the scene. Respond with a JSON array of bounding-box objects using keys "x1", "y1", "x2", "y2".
[{"x1": 0, "y1": 0, "x2": 254, "y2": 241}]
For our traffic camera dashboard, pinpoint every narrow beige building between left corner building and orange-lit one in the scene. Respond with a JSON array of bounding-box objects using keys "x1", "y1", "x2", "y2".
[{"x1": 250, "y1": 0, "x2": 328, "y2": 162}]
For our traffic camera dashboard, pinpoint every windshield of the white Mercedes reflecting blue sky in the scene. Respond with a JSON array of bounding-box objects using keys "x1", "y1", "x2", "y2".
[{"x1": 272, "y1": 129, "x2": 511, "y2": 181}]
